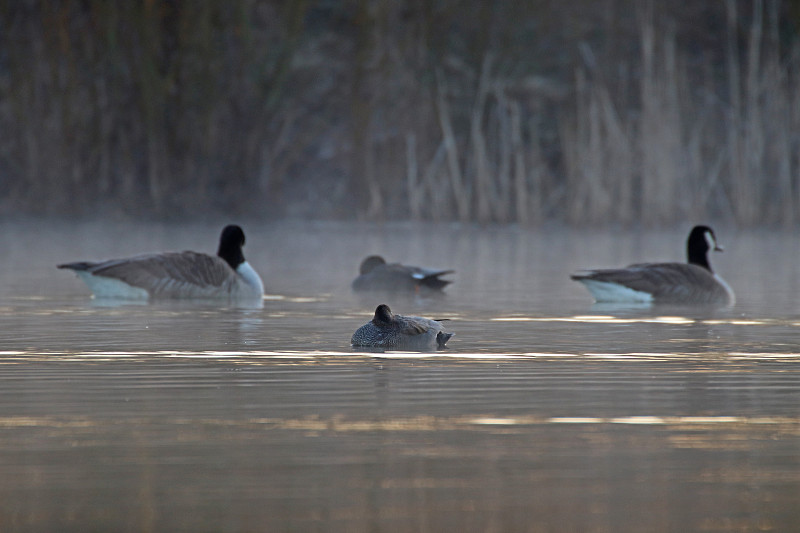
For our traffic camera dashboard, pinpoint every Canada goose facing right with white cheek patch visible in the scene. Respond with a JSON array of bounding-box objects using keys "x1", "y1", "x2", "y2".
[{"x1": 570, "y1": 226, "x2": 734, "y2": 305}]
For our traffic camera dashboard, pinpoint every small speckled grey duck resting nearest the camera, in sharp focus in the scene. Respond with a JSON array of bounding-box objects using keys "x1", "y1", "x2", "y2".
[{"x1": 350, "y1": 304, "x2": 454, "y2": 351}]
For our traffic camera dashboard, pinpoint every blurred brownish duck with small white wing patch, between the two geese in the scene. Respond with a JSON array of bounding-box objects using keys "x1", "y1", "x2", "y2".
[{"x1": 352, "y1": 255, "x2": 455, "y2": 292}]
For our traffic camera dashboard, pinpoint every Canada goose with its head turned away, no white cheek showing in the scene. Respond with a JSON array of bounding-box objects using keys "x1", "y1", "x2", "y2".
[{"x1": 58, "y1": 225, "x2": 264, "y2": 301}]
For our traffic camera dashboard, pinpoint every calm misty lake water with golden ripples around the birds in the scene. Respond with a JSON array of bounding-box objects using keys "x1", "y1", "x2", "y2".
[{"x1": 0, "y1": 221, "x2": 800, "y2": 532}]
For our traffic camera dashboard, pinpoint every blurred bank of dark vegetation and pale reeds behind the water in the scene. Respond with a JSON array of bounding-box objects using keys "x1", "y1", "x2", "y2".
[{"x1": 0, "y1": 0, "x2": 800, "y2": 226}]
